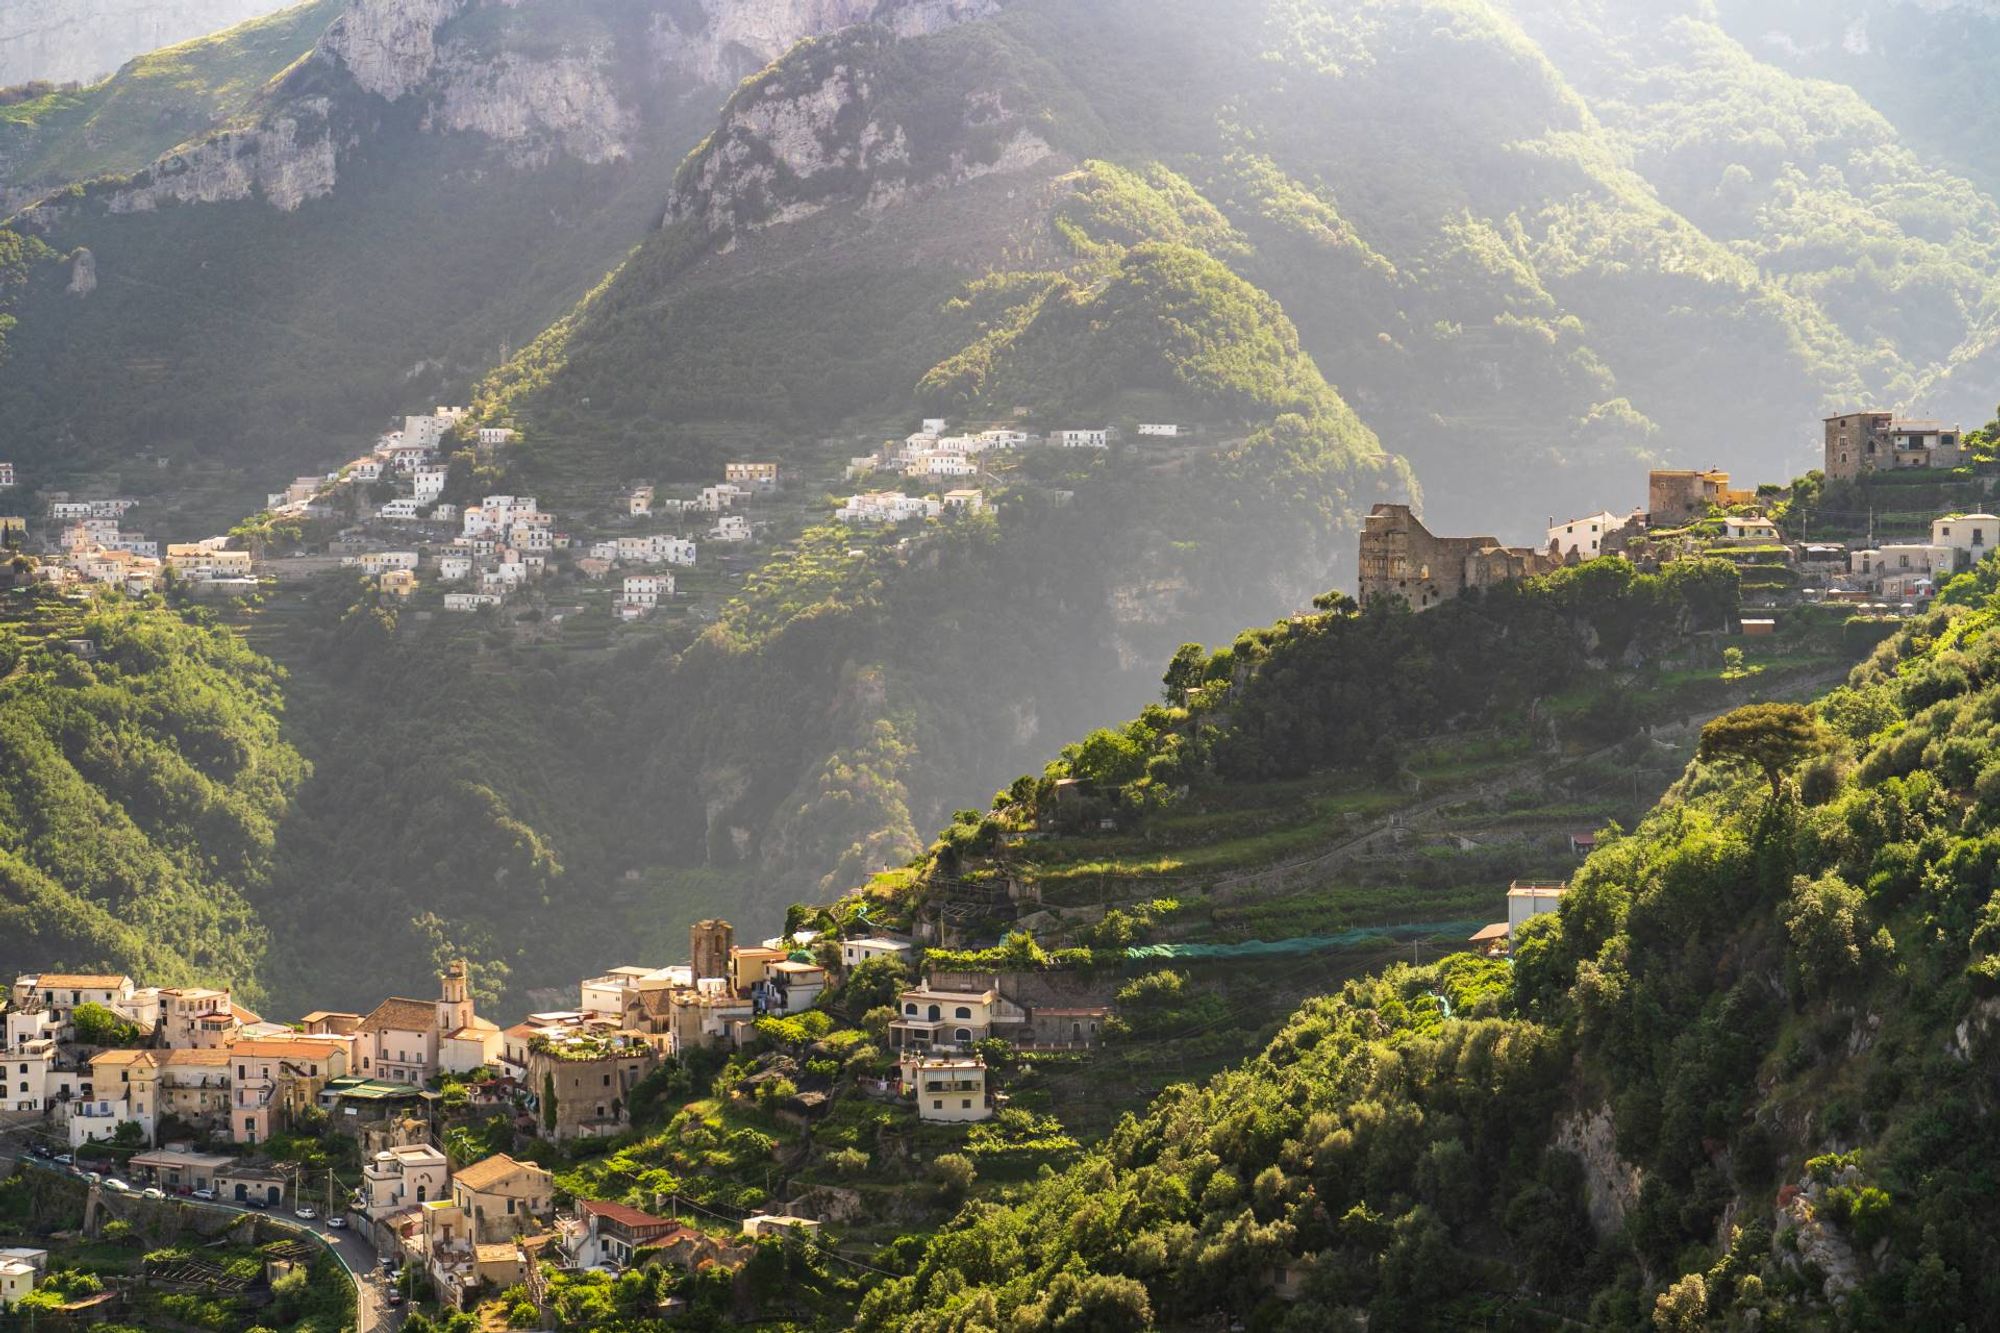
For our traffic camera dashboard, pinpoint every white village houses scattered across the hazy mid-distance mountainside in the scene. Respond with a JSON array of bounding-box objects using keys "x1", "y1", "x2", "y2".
[{"x1": 0, "y1": 406, "x2": 1160, "y2": 624}]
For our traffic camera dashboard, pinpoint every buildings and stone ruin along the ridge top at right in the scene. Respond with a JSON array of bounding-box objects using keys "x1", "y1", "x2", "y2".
[{"x1": 1360, "y1": 412, "x2": 2000, "y2": 612}]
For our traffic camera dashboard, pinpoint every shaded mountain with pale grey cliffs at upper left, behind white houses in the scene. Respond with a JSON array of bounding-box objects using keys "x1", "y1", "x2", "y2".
[{"x1": 0, "y1": 0, "x2": 984, "y2": 534}]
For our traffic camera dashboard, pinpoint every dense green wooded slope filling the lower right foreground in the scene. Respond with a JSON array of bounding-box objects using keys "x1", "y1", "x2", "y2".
[{"x1": 858, "y1": 560, "x2": 2000, "y2": 1329}]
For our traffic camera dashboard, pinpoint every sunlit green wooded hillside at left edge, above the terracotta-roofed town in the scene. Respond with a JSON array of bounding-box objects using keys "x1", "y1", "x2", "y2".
[{"x1": 0, "y1": 592, "x2": 306, "y2": 1003}]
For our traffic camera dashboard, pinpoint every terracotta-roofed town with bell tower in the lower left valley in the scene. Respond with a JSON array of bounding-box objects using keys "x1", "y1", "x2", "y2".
[{"x1": 0, "y1": 921, "x2": 1110, "y2": 1307}]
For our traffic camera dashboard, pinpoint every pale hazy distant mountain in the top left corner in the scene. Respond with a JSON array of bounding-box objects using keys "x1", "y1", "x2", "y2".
[{"x1": 0, "y1": 0, "x2": 282, "y2": 88}]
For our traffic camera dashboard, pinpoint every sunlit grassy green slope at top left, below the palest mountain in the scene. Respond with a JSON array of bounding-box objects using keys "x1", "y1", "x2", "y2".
[{"x1": 0, "y1": 0, "x2": 342, "y2": 190}]
